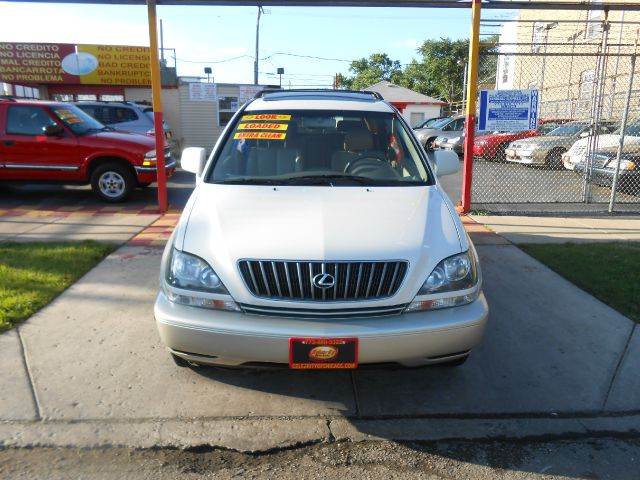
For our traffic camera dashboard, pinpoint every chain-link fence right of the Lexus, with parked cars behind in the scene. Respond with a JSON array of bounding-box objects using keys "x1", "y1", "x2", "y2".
[{"x1": 471, "y1": 18, "x2": 640, "y2": 212}]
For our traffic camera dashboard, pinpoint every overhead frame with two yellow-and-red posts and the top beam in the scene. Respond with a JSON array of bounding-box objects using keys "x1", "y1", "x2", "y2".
[{"x1": 5, "y1": 0, "x2": 640, "y2": 213}]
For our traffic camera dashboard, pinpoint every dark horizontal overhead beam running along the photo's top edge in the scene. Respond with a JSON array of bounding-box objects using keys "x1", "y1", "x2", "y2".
[{"x1": 5, "y1": 0, "x2": 640, "y2": 11}]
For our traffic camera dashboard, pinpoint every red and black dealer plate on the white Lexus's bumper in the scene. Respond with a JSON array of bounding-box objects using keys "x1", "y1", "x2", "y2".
[{"x1": 289, "y1": 338, "x2": 358, "y2": 369}]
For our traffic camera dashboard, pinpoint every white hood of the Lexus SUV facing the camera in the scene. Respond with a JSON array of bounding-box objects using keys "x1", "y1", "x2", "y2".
[{"x1": 176, "y1": 183, "x2": 468, "y2": 302}]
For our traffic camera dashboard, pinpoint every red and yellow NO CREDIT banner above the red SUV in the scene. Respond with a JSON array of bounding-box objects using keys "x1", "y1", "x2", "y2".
[{"x1": 0, "y1": 42, "x2": 151, "y2": 86}]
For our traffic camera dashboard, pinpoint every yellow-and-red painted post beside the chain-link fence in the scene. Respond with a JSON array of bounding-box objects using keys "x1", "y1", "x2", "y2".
[{"x1": 459, "y1": 0, "x2": 481, "y2": 213}]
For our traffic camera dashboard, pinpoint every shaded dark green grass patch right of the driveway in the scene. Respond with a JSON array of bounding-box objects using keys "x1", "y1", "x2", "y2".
[{"x1": 518, "y1": 242, "x2": 640, "y2": 323}]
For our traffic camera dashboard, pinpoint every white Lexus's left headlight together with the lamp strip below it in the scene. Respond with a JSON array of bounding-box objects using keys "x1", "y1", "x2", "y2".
[{"x1": 163, "y1": 248, "x2": 241, "y2": 312}]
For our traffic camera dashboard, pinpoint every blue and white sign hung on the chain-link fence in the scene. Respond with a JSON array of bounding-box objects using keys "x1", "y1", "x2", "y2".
[{"x1": 478, "y1": 90, "x2": 539, "y2": 132}]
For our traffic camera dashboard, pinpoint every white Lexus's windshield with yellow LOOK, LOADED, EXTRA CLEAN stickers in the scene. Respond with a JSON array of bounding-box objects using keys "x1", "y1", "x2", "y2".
[{"x1": 206, "y1": 110, "x2": 431, "y2": 186}]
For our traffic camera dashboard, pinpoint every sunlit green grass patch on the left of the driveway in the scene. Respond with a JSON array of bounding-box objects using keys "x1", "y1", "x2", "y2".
[{"x1": 0, "y1": 241, "x2": 115, "y2": 332}]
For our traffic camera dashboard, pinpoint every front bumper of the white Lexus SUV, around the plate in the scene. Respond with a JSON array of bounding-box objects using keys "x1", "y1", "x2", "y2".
[{"x1": 154, "y1": 292, "x2": 489, "y2": 367}]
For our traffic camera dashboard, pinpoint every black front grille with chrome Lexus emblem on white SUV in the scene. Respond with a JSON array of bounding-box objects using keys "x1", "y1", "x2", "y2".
[{"x1": 238, "y1": 260, "x2": 408, "y2": 302}]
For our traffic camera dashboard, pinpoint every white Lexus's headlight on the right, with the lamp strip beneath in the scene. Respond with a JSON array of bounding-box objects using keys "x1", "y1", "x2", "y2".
[{"x1": 405, "y1": 248, "x2": 480, "y2": 312}]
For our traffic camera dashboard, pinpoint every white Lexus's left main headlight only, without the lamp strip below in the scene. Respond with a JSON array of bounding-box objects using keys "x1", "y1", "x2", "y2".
[{"x1": 167, "y1": 248, "x2": 229, "y2": 295}]
